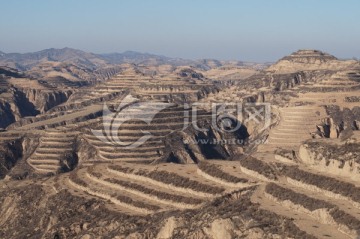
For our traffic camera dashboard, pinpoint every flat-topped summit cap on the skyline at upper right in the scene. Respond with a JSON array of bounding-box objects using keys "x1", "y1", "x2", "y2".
[{"x1": 280, "y1": 50, "x2": 338, "y2": 64}]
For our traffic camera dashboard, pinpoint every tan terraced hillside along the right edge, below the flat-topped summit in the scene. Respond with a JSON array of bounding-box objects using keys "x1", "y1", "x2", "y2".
[{"x1": 186, "y1": 49, "x2": 360, "y2": 238}]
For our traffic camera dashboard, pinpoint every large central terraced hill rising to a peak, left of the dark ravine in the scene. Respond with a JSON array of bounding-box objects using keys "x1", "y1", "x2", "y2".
[{"x1": 0, "y1": 65, "x2": 236, "y2": 175}]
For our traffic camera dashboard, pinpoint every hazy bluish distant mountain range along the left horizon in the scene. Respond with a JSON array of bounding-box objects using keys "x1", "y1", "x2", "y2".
[{"x1": 0, "y1": 48, "x2": 264, "y2": 70}]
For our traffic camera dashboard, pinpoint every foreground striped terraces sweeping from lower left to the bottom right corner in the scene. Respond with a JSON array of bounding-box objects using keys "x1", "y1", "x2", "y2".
[{"x1": 52, "y1": 155, "x2": 360, "y2": 238}]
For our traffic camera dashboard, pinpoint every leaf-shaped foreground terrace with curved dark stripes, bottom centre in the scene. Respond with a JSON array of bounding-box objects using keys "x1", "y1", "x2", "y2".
[{"x1": 59, "y1": 163, "x2": 252, "y2": 214}]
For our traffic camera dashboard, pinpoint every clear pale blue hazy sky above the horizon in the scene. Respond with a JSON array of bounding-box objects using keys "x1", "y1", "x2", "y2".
[{"x1": 0, "y1": 0, "x2": 360, "y2": 61}]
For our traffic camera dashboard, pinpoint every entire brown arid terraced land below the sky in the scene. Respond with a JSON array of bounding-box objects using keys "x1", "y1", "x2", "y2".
[{"x1": 0, "y1": 48, "x2": 360, "y2": 239}]
